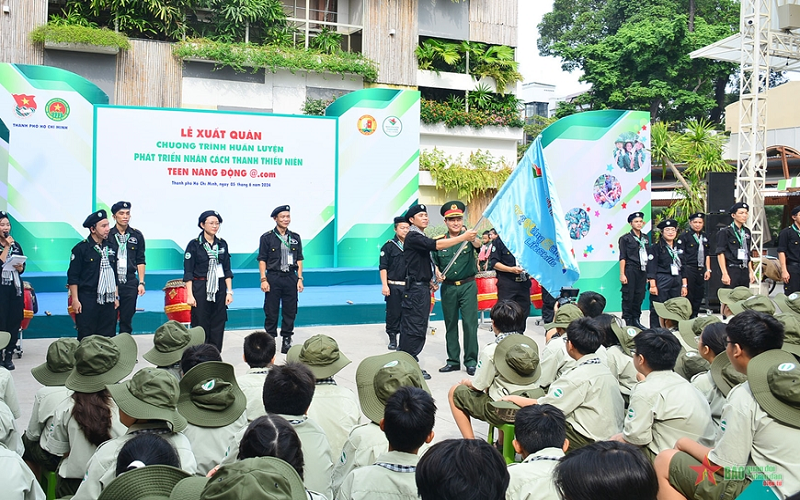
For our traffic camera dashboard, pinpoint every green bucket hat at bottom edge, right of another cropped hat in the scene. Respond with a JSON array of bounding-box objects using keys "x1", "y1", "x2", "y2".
[{"x1": 200, "y1": 457, "x2": 308, "y2": 500}]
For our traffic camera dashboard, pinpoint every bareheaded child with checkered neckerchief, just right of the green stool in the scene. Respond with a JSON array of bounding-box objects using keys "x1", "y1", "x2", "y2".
[{"x1": 506, "y1": 405, "x2": 569, "y2": 500}]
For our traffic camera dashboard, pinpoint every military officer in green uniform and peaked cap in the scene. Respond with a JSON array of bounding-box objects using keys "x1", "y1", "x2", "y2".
[{"x1": 433, "y1": 201, "x2": 481, "y2": 375}]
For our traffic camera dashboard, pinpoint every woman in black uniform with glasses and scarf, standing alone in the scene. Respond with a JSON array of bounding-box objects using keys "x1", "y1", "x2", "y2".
[{"x1": 183, "y1": 210, "x2": 233, "y2": 352}]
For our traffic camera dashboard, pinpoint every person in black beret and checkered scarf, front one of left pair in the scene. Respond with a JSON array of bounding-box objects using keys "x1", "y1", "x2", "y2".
[{"x1": 67, "y1": 210, "x2": 119, "y2": 340}]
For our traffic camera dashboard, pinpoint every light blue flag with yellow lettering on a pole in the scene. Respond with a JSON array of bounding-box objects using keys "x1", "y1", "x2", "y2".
[{"x1": 483, "y1": 136, "x2": 580, "y2": 297}]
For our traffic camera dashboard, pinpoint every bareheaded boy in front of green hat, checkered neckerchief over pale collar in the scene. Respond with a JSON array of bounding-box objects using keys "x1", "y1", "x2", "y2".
[{"x1": 336, "y1": 387, "x2": 436, "y2": 500}]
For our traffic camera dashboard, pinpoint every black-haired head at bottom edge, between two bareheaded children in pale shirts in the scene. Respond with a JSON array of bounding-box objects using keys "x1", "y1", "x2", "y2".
[{"x1": 416, "y1": 439, "x2": 508, "y2": 500}]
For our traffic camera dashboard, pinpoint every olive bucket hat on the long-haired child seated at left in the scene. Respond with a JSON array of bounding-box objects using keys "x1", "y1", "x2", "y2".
[{"x1": 64, "y1": 333, "x2": 138, "y2": 393}]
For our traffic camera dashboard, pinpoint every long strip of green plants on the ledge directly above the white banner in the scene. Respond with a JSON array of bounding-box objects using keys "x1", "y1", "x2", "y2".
[{"x1": 173, "y1": 39, "x2": 378, "y2": 82}]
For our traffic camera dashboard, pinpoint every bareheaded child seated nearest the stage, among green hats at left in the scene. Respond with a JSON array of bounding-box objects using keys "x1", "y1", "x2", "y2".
[{"x1": 236, "y1": 332, "x2": 275, "y2": 422}]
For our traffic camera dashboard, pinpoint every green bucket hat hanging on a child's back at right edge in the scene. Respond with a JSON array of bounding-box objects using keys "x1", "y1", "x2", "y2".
[{"x1": 747, "y1": 349, "x2": 800, "y2": 427}]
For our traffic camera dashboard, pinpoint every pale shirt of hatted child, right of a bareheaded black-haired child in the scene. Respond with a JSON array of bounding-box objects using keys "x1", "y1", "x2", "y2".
[{"x1": 308, "y1": 382, "x2": 361, "y2": 458}]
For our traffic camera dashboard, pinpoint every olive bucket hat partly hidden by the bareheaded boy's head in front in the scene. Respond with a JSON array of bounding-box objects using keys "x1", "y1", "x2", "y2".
[{"x1": 356, "y1": 351, "x2": 431, "y2": 424}]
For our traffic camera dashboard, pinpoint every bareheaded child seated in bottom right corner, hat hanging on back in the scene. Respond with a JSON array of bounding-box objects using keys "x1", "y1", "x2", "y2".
[{"x1": 655, "y1": 311, "x2": 800, "y2": 500}]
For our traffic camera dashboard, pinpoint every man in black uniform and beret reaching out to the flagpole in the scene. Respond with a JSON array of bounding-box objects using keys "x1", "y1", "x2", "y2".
[{"x1": 398, "y1": 204, "x2": 478, "y2": 380}]
